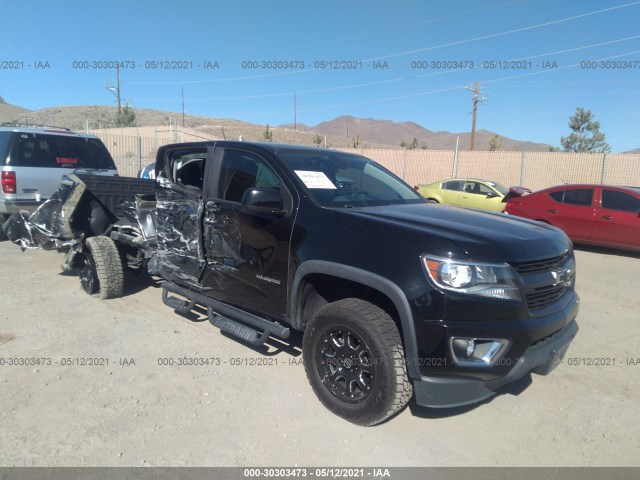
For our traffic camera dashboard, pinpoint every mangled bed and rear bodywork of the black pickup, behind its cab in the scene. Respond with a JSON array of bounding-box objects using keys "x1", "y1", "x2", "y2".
[{"x1": 2, "y1": 174, "x2": 155, "y2": 271}]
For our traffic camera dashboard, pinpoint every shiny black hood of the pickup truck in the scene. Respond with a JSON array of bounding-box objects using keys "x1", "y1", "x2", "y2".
[{"x1": 342, "y1": 204, "x2": 571, "y2": 262}]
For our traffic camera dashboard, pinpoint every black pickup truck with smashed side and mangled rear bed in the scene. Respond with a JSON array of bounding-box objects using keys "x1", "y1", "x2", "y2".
[{"x1": 4, "y1": 141, "x2": 578, "y2": 425}]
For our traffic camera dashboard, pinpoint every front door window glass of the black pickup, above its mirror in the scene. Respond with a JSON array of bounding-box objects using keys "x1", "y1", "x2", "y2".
[{"x1": 218, "y1": 150, "x2": 281, "y2": 203}]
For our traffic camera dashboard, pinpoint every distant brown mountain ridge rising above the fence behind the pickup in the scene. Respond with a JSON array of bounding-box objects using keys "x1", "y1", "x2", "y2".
[{"x1": 284, "y1": 115, "x2": 549, "y2": 152}]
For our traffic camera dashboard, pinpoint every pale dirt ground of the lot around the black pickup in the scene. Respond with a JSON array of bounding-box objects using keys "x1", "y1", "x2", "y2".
[{"x1": 0, "y1": 242, "x2": 640, "y2": 467}]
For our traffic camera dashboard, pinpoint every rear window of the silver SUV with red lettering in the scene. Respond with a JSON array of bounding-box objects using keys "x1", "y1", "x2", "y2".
[{"x1": 8, "y1": 133, "x2": 116, "y2": 170}]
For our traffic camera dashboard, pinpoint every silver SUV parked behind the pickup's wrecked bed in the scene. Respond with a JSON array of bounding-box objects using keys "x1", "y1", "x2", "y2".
[{"x1": 0, "y1": 126, "x2": 118, "y2": 221}]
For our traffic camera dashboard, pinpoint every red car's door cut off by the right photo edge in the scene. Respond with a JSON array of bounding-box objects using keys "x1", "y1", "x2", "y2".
[{"x1": 591, "y1": 187, "x2": 640, "y2": 248}]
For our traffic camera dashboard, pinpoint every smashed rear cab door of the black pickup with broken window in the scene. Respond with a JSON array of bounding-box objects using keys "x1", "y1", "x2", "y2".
[{"x1": 156, "y1": 145, "x2": 208, "y2": 286}]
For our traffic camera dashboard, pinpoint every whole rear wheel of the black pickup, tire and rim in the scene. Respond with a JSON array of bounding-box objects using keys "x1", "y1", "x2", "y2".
[{"x1": 80, "y1": 236, "x2": 124, "y2": 299}]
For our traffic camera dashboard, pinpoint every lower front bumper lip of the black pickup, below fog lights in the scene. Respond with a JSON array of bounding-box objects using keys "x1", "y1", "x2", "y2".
[{"x1": 414, "y1": 320, "x2": 578, "y2": 408}]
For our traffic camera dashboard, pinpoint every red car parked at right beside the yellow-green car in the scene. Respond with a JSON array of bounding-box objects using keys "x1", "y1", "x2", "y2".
[{"x1": 505, "y1": 185, "x2": 640, "y2": 251}]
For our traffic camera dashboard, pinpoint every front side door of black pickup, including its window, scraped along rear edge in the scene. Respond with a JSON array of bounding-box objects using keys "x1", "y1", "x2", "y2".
[{"x1": 202, "y1": 147, "x2": 294, "y2": 317}]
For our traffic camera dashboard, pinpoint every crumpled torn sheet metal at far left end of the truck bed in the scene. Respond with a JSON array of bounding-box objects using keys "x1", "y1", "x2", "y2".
[{"x1": 2, "y1": 187, "x2": 80, "y2": 251}]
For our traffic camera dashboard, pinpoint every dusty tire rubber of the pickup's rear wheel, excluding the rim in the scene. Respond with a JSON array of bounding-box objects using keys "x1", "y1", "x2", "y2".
[{"x1": 86, "y1": 236, "x2": 124, "y2": 299}]
